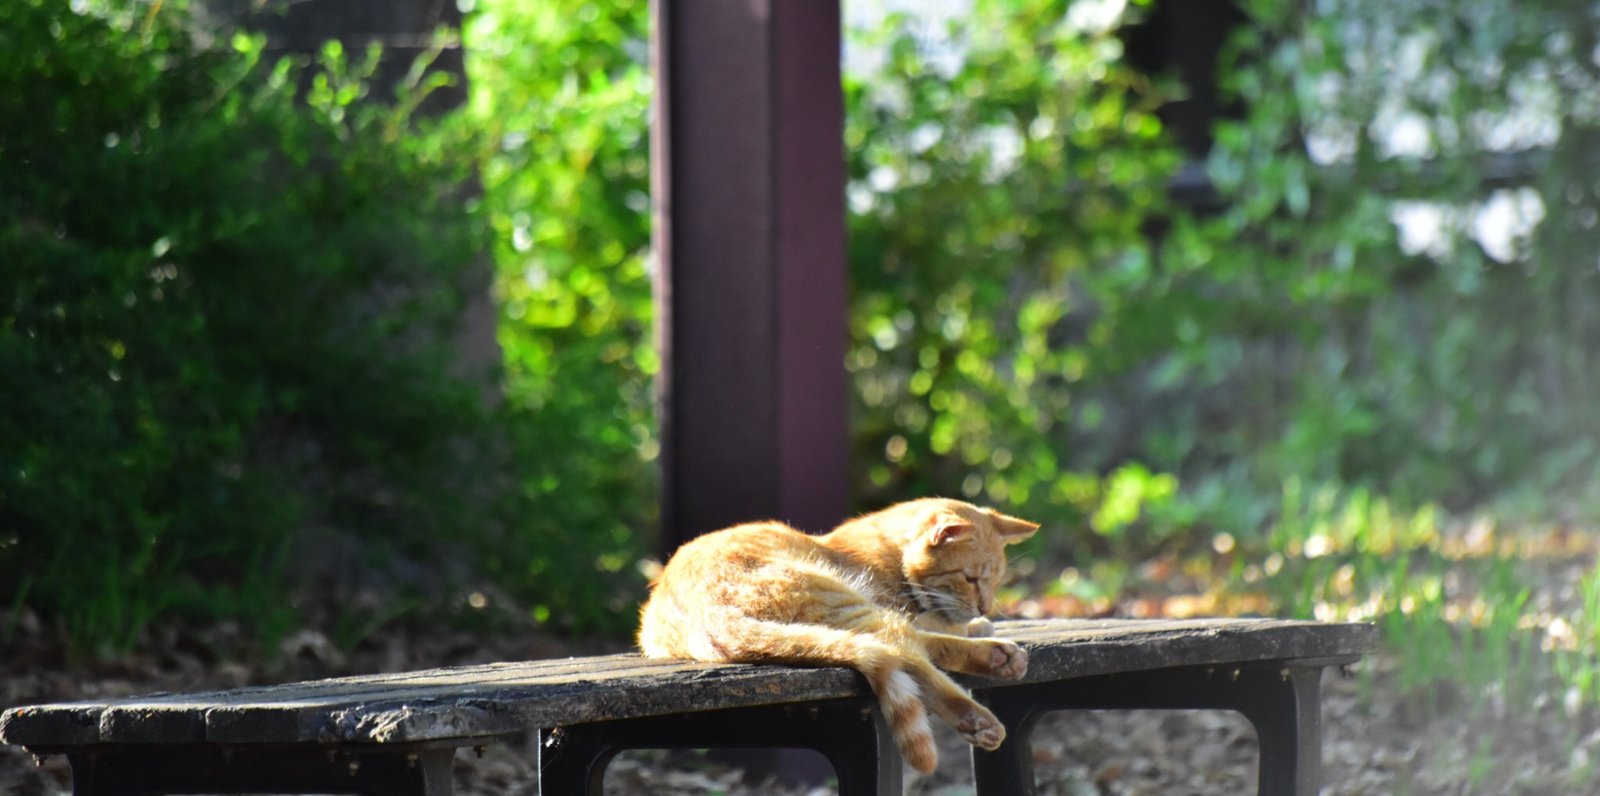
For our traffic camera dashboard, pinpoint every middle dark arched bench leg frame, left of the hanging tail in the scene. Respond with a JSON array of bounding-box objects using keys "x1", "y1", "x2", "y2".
[{"x1": 539, "y1": 700, "x2": 902, "y2": 796}]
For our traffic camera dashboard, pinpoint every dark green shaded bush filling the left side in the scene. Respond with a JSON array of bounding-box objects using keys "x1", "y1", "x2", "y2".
[{"x1": 0, "y1": 0, "x2": 493, "y2": 647}]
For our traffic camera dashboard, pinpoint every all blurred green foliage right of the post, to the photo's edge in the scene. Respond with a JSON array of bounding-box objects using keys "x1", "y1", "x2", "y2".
[{"x1": 846, "y1": 0, "x2": 1600, "y2": 556}]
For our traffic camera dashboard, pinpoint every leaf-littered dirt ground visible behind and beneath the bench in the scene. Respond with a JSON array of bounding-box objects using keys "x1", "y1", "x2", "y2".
[{"x1": 0, "y1": 616, "x2": 1600, "y2": 796}]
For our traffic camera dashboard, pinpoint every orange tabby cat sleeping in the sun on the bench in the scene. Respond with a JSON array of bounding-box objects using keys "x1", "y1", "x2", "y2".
[{"x1": 638, "y1": 499, "x2": 1038, "y2": 772}]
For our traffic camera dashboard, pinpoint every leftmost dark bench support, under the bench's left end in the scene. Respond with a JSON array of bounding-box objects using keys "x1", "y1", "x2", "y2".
[{"x1": 69, "y1": 746, "x2": 454, "y2": 796}]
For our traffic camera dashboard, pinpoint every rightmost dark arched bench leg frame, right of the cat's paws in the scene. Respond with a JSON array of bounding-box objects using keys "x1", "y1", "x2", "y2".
[{"x1": 973, "y1": 663, "x2": 1322, "y2": 796}]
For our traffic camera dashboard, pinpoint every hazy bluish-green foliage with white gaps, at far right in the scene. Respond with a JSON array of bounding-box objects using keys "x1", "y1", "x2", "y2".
[{"x1": 1170, "y1": 0, "x2": 1600, "y2": 507}]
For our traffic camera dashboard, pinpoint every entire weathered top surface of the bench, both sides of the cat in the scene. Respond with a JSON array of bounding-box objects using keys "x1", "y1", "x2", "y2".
[{"x1": 0, "y1": 619, "x2": 1378, "y2": 748}]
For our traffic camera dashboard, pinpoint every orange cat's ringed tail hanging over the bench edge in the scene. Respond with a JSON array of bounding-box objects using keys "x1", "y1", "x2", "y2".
[{"x1": 706, "y1": 617, "x2": 939, "y2": 774}]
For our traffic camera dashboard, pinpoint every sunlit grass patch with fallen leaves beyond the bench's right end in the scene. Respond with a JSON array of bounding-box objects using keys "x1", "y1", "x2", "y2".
[{"x1": 1227, "y1": 483, "x2": 1600, "y2": 793}]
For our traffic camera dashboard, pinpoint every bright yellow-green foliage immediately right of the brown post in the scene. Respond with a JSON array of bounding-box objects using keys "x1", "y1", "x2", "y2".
[{"x1": 845, "y1": 2, "x2": 1179, "y2": 559}]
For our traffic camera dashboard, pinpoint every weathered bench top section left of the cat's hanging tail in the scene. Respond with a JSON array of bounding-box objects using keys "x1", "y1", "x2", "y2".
[{"x1": 12, "y1": 655, "x2": 866, "y2": 745}]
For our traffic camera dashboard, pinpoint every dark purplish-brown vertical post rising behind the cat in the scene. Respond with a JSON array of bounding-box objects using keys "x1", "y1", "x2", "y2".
[{"x1": 651, "y1": 0, "x2": 848, "y2": 553}]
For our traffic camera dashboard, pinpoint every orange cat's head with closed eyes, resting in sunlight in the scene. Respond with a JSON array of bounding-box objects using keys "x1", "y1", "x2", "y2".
[{"x1": 894, "y1": 497, "x2": 1038, "y2": 622}]
